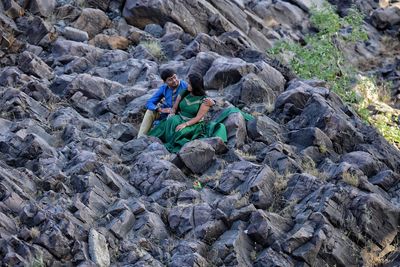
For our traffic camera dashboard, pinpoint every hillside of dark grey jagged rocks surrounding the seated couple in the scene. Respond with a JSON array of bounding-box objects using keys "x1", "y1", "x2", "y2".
[{"x1": 0, "y1": 0, "x2": 400, "y2": 267}]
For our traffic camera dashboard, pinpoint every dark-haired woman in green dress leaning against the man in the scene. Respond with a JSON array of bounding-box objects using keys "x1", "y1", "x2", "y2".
[{"x1": 149, "y1": 73, "x2": 227, "y2": 153}]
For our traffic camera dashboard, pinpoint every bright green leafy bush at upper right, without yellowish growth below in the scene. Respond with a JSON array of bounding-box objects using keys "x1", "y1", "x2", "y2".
[{"x1": 269, "y1": 4, "x2": 367, "y2": 103}]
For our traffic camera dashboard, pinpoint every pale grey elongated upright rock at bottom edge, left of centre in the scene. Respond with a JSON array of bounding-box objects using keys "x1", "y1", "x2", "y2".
[{"x1": 89, "y1": 228, "x2": 110, "y2": 267}]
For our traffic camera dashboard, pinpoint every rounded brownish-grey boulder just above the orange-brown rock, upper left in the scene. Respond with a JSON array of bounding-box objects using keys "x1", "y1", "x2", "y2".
[{"x1": 74, "y1": 8, "x2": 110, "y2": 38}]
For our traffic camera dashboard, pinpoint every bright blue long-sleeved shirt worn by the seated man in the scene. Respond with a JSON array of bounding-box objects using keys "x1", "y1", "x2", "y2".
[{"x1": 146, "y1": 80, "x2": 188, "y2": 111}]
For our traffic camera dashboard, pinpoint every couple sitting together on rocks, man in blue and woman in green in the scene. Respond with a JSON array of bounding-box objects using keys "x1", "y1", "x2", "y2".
[{"x1": 138, "y1": 69, "x2": 251, "y2": 153}]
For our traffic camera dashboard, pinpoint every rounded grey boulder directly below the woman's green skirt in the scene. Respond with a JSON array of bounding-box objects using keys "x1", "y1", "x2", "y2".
[{"x1": 179, "y1": 140, "x2": 215, "y2": 173}]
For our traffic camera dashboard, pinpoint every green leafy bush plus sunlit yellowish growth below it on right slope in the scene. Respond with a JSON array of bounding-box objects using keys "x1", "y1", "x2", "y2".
[{"x1": 268, "y1": 3, "x2": 400, "y2": 149}]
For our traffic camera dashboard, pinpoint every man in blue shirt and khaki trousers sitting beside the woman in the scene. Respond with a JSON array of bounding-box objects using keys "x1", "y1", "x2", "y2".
[{"x1": 137, "y1": 69, "x2": 188, "y2": 138}]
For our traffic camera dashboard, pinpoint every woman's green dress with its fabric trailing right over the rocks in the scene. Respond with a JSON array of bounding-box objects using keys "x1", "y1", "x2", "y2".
[{"x1": 149, "y1": 94, "x2": 255, "y2": 153}]
